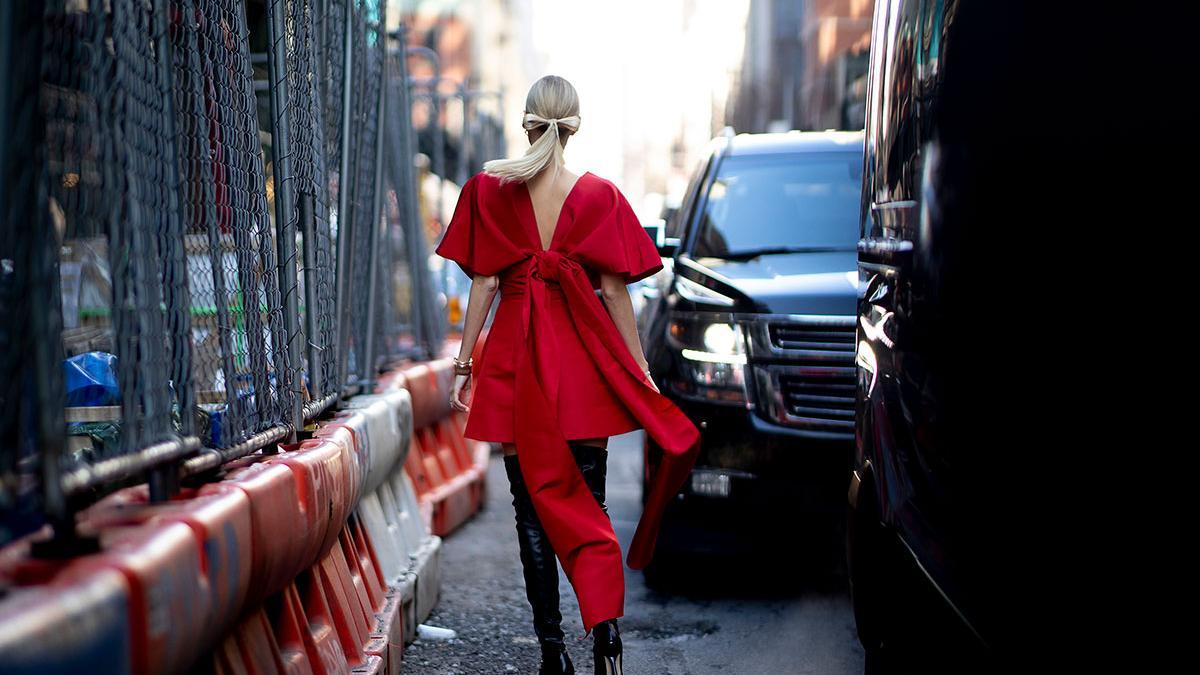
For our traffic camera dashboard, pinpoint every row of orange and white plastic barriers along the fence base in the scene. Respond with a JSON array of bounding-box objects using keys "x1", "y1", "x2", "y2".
[{"x1": 0, "y1": 359, "x2": 463, "y2": 675}]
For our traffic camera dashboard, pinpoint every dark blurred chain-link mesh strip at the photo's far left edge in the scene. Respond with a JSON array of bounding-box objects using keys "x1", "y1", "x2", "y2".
[{"x1": 0, "y1": 2, "x2": 62, "y2": 535}]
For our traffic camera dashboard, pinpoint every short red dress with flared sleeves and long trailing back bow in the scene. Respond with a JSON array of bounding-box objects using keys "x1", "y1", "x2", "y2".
[{"x1": 437, "y1": 172, "x2": 700, "y2": 631}]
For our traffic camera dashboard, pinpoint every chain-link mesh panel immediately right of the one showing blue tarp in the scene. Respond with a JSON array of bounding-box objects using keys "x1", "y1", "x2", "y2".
[{"x1": 172, "y1": 0, "x2": 287, "y2": 448}]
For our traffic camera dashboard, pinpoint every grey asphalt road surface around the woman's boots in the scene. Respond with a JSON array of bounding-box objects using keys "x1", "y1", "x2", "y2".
[{"x1": 404, "y1": 431, "x2": 863, "y2": 675}]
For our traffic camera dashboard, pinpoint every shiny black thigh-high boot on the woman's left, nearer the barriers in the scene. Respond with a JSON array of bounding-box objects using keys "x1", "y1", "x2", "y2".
[{"x1": 504, "y1": 455, "x2": 575, "y2": 675}]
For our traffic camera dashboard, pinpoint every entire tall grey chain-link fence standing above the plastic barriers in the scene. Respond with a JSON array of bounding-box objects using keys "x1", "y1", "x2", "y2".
[{"x1": 0, "y1": 0, "x2": 445, "y2": 543}]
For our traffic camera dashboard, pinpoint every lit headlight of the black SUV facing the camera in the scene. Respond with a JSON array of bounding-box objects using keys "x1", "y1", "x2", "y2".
[{"x1": 668, "y1": 312, "x2": 746, "y2": 404}]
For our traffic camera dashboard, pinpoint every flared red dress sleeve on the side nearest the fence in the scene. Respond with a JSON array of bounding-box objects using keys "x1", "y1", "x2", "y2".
[{"x1": 434, "y1": 173, "x2": 522, "y2": 279}]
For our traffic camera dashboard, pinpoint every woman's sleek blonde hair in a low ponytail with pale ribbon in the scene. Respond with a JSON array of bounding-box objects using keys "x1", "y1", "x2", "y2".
[{"x1": 484, "y1": 74, "x2": 580, "y2": 184}]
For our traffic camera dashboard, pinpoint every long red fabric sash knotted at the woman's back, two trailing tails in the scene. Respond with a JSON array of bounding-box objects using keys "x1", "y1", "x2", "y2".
[{"x1": 514, "y1": 251, "x2": 700, "y2": 632}]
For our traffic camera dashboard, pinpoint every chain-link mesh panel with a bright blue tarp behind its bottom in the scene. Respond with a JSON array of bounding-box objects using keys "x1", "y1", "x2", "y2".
[{"x1": 40, "y1": 0, "x2": 191, "y2": 464}]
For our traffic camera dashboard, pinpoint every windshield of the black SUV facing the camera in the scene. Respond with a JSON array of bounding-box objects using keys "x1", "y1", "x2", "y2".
[{"x1": 692, "y1": 153, "x2": 863, "y2": 258}]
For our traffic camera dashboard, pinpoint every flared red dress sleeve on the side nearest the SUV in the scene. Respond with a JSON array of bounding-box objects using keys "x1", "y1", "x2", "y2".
[{"x1": 574, "y1": 181, "x2": 662, "y2": 285}]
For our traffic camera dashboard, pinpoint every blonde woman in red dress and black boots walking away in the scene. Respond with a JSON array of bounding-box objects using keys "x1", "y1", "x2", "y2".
[{"x1": 437, "y1": 76, "x2": 700, "y2": 674}]
